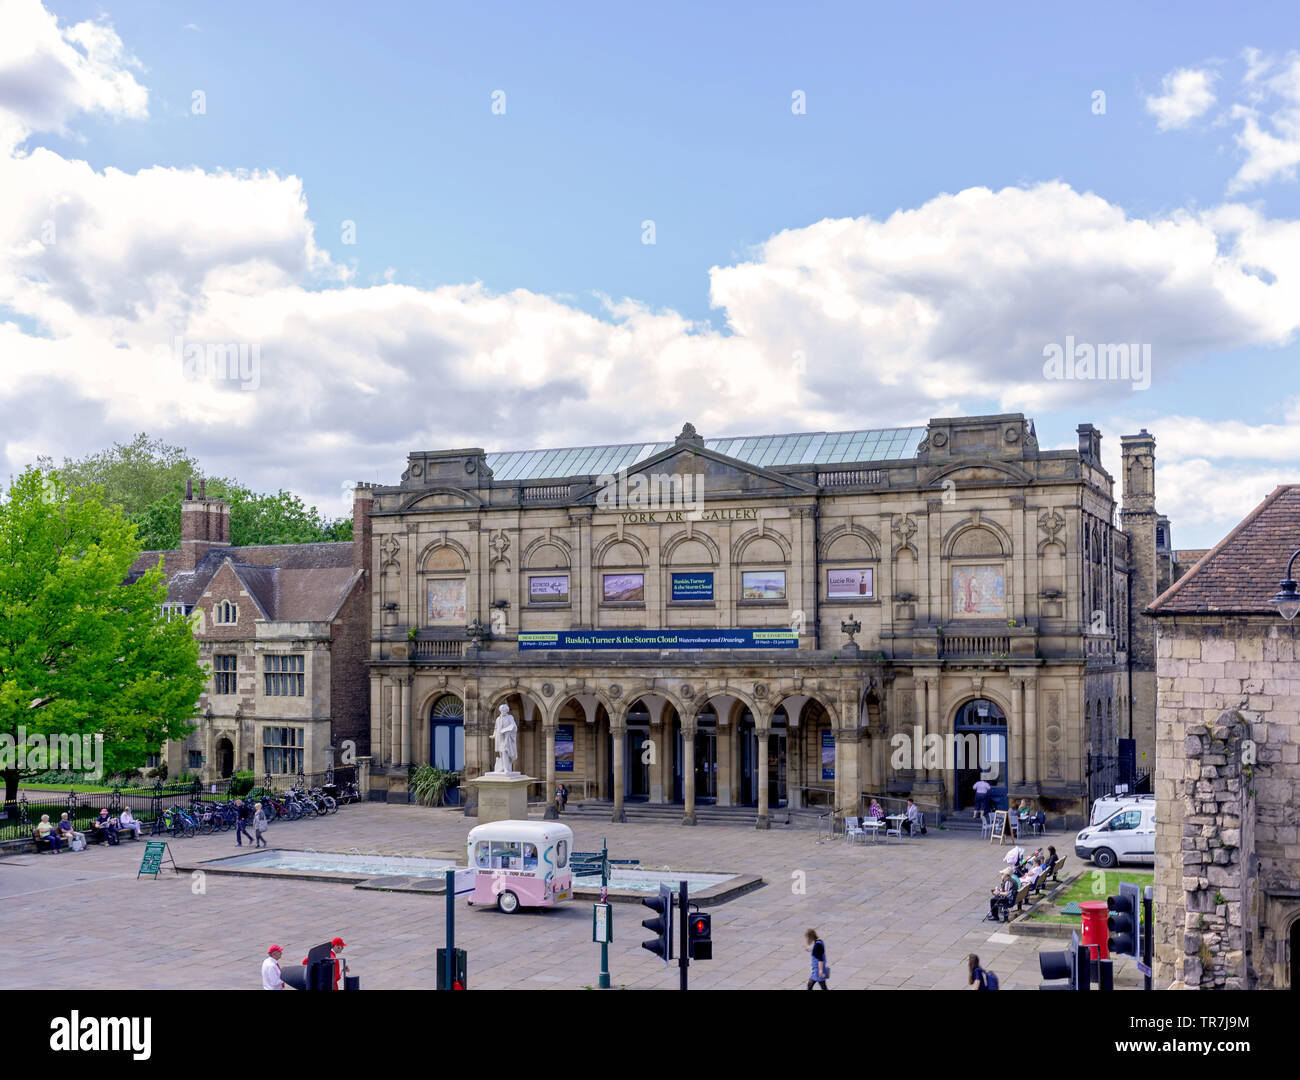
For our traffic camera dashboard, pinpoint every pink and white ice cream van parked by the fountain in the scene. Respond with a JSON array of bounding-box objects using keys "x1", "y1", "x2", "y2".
[{"x1": 467, "y1": 821, "x2": 573, "y2": 915}]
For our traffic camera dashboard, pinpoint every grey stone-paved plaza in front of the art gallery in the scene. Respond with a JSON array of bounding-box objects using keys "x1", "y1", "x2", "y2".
[{"x1": 0, "y1": 804, "x2": 1138, "y2": 990}]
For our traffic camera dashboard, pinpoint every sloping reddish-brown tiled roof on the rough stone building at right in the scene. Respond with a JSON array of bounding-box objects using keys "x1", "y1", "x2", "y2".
[{"x1": 1147, "y1": 483, "x2": 1300, "y2": 619}]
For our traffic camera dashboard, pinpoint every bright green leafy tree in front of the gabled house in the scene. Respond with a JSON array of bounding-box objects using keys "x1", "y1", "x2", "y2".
[{"x1": 0, "y1": 468, "x2": 207, "y2": 801}]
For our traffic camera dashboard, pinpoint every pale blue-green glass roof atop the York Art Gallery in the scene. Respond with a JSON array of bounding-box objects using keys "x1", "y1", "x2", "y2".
[{"x1": 486, "y1": 428, "x2": 926, "y2": 481}]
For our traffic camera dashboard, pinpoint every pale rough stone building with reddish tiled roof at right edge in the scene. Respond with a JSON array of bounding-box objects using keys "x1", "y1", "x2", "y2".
[{"x1": 1149, "y1": 485, "x2": 1300, "y2": 989}]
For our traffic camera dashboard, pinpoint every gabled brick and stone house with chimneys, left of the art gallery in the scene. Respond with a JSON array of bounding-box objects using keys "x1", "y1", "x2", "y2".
[{"x1": 133, "y1": 485, "x2": 369, "y2": 780}]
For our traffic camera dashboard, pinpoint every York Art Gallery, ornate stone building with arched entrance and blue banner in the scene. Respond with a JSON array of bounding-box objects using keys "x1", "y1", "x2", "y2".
[{"x1": 356, "y1": 413, "x2": 1174, "y2": 827}]
